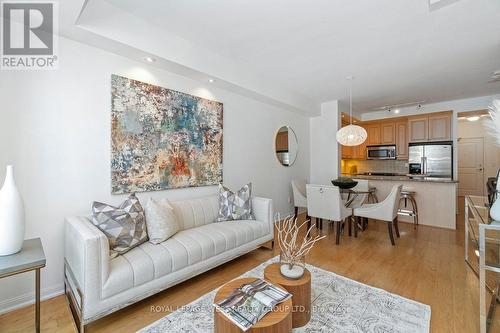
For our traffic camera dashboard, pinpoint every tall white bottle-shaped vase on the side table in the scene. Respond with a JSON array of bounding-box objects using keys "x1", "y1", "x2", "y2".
[{"x1": 0, "y1": 165, "x2": 25, "y2": 256}]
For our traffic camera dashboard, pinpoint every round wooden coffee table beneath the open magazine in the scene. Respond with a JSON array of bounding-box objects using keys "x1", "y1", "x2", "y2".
[{"x1": 214, "y1": 278, "x2": 292, "y2": 333}]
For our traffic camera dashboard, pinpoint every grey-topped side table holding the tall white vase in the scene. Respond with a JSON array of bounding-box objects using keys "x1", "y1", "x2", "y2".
[{"x1": 0, "y1": 238, "x2": 46, "y2": 333}]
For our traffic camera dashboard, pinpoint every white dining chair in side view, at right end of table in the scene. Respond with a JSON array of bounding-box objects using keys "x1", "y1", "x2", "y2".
[{"x1": 354, "y1": 185, "x2": 403, "y2": 245}]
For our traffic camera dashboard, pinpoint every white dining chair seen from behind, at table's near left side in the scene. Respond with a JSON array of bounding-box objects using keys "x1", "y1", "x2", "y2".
[{"x1": 306, "y1": 184, "x2": 352, "y2": 245}]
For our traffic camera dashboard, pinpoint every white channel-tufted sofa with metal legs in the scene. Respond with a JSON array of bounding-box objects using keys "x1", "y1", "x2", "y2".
[{"x1": 64, "y1": 195, "x2": 274, "y2": 332}]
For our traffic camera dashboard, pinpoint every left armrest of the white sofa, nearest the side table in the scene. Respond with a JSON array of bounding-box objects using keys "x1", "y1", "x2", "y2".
[{"x1": 64, "y1": 217, "x2": 109, "y2": 296}]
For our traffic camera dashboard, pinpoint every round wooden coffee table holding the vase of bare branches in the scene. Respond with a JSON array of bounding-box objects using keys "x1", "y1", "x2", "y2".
[{"x1": 264, "y1": 263, "x2": 311, "y2": 328}]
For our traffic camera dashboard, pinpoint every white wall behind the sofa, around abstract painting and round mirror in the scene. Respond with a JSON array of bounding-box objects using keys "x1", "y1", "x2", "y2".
[{"x1": 0, "y1": 38, "x2": 310, "y2": 312}]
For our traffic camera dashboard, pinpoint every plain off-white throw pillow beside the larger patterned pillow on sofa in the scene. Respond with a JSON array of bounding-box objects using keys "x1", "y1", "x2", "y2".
[{"x1": 145, "y1": 199, "x2": 179, "y2": 244}]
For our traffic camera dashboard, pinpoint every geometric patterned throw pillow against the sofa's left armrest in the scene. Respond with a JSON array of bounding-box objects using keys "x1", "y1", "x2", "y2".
[{"x1": 92, "y1": 193, "x2": 148, "y2": 258}]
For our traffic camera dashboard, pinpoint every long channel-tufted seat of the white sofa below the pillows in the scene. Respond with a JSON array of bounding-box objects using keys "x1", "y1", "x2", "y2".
[{"x1": 99, "y1": 220, "x2": 268, "y2": 298}]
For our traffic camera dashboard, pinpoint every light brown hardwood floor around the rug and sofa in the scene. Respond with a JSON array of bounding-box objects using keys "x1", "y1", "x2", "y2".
[{"x1": 0, "y1": 214, "x2": 500, "y2": 333}]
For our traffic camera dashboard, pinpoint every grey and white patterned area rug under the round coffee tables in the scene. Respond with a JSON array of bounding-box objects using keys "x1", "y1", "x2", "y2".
[{"x1": 139, "y1": 257, "x2": 431, "y2": 333}]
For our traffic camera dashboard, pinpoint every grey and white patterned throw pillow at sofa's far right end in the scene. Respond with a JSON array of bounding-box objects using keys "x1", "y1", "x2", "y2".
[{"x1": 217, "y1": 183, "x2": 253, "y2": 222}]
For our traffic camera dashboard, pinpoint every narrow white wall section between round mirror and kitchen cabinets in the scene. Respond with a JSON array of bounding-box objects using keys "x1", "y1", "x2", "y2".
[{"x1": 309, "y1": 101, "x2": 340, "y2": 184}]
